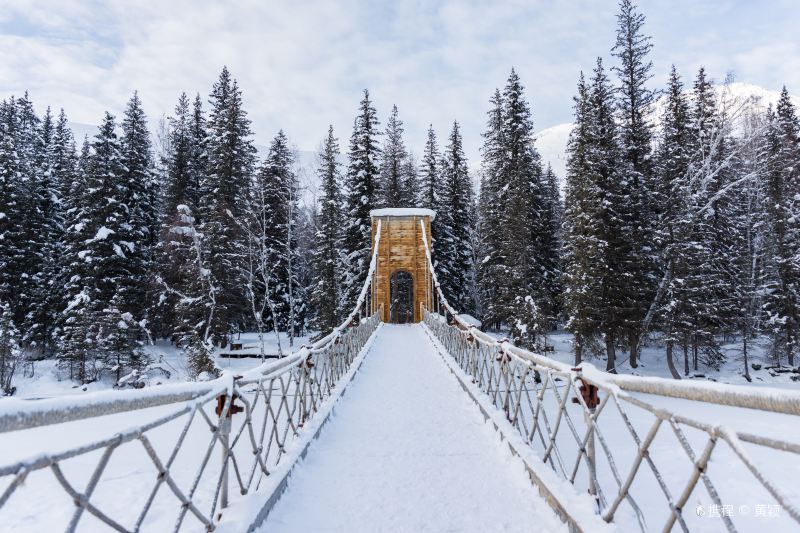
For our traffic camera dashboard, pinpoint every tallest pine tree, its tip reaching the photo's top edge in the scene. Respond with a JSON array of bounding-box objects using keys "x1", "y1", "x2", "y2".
[{"x1": 612, "y1": 0, "x2": 654, "y2": 368}]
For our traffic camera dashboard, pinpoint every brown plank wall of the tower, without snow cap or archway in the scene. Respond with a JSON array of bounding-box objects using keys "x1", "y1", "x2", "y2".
[{"x1": 372, "y1": 216, "x2": 431, "y2": 322}]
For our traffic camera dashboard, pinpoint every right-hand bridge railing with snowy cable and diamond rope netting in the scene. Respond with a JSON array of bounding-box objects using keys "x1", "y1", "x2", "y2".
[{"x1": 422, "y1": 219, "x2": 800, "y2": 531}]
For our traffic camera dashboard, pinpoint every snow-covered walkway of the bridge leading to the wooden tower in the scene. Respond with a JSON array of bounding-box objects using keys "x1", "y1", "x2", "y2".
[{"x1": 261, "y1": 325, "x2": 566, "y2": 533}]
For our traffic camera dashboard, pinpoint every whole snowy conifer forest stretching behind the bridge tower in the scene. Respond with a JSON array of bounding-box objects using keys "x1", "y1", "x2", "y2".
[{"x1": 0, "y1": 0, "x2": 800, "y2": 395}]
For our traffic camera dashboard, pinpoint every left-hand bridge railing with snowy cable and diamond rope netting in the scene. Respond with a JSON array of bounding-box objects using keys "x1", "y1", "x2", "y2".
[{"x1": 0, "y1": 221, "x2": 380, "y2": 532}]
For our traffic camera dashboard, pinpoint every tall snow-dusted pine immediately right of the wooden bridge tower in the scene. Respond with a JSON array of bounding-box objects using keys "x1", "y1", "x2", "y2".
[{"x1": 435, "y1": 122, "x2": 474, "y2": 313}]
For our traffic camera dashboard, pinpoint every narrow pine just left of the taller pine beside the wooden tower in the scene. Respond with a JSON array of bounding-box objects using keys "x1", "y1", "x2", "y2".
[{"x1": 310, "y1": 126, "x2": 345, "y2": 331}]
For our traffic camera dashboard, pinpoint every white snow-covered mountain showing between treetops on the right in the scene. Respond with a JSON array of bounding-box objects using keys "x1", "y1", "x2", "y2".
[{"x1": 534, "y1": 82, "x2": 800, "y2": 189}]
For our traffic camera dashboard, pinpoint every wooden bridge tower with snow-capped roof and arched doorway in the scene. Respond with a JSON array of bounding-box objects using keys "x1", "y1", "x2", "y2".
[{"x1": 370, "y1": 208, "x2": 436, "y2": 322}]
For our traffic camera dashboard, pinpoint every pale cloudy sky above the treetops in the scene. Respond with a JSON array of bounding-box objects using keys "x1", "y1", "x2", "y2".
[{"x1": 0, "y1": 0, "x2": 800, "y2": 161}]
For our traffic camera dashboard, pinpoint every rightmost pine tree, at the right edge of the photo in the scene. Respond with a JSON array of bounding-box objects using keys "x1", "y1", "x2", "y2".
[{"x1": 765, "y1": 87, "x2": 800, "y2": 366}]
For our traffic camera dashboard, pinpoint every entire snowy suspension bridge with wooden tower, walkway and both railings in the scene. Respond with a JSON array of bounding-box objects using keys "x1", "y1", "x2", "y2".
[{"x1": 0, "y1": 209, "x2": 800, "y2": 532}]
